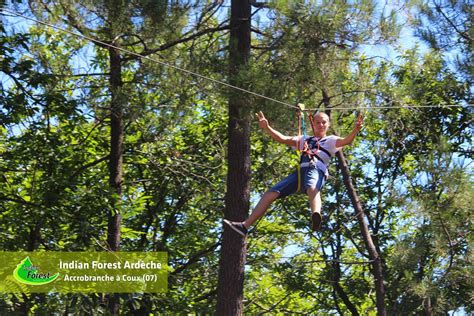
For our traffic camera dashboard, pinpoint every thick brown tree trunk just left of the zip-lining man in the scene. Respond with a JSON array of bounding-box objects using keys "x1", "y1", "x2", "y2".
[{"x1": 216, "y1": 0, "x2": 251, "y2": 316}]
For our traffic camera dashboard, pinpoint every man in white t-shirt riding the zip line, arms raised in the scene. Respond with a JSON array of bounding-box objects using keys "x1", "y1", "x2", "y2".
[{"x1": 224, "y1": 111, "x2": 363, "y2": 237}]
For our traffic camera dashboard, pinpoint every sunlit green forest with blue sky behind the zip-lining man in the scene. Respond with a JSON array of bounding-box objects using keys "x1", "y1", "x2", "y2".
[{"x1": 0, "y1": 0, "x2": 474, "y2": 315}]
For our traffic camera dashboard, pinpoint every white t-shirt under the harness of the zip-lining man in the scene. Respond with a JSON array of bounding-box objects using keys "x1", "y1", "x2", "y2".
[{"x1": 293, "y1": 135, "x2": 341, "y2": 174}]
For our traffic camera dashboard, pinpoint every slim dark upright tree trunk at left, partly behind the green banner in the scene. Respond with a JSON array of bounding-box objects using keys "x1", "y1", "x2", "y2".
[{"x1": 107, "y1": 48, "x2": 124, "y2": 315}]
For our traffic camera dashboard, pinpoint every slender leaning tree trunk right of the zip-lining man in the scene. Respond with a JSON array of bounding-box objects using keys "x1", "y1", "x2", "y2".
[{"x1": 336, "y1": 151, "x2": 387, "y2": 316}]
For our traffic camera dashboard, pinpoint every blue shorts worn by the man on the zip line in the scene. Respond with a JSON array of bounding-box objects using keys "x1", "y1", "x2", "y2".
[{"x1": 269, "y1": 166, "x2": 326, "y2": 198}]
